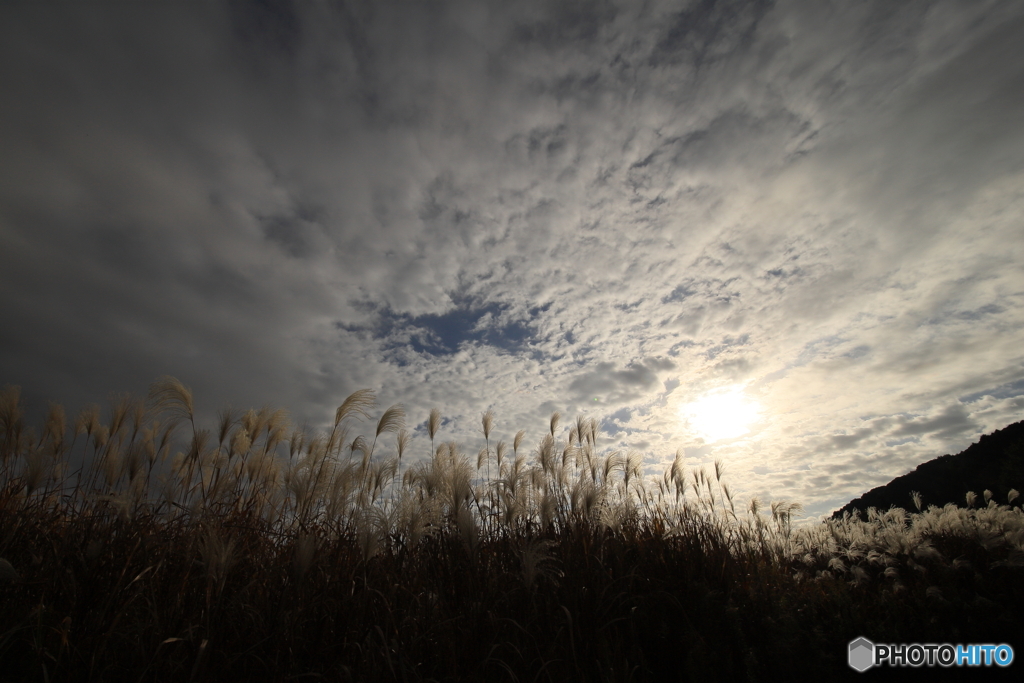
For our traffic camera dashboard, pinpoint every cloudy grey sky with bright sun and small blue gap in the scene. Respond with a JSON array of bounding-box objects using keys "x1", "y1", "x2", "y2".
[{"x1": 0, "y1": 0, "x2": 1024, "y2": 519}]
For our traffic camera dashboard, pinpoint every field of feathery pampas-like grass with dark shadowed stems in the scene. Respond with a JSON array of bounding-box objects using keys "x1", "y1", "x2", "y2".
[{"x1": 0, "y1": 378, "x2": 1024, "y2": 683}]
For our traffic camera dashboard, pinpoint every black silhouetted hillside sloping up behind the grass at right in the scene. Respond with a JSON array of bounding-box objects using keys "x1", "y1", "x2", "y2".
[{"x1": 833, "y1": 422, "x2": 1024, "y2": 519}]
